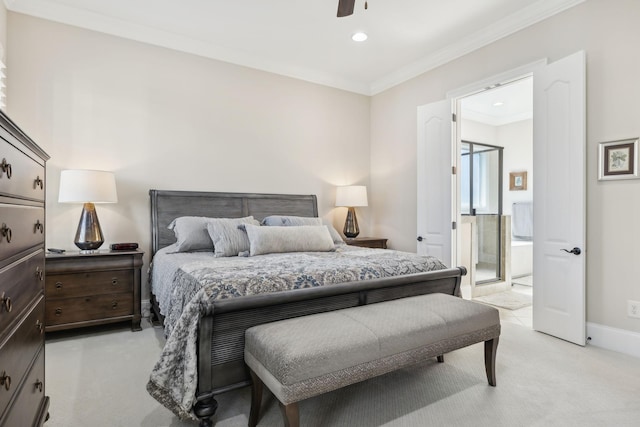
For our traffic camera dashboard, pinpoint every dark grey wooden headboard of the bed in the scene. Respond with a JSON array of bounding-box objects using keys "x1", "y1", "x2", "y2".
[{"x1": 149, "y1": 190, "x2": 318, "y2": 256}]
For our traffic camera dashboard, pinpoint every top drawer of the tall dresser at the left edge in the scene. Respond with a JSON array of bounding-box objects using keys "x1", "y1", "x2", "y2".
[{"x1": 0, "y1": 139, "x2": 45, "y2": 201}]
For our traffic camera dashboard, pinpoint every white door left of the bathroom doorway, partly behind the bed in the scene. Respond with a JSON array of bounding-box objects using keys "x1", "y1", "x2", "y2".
[{"x1": 417, "y1": 100, "x2": 454, "y2": 267}]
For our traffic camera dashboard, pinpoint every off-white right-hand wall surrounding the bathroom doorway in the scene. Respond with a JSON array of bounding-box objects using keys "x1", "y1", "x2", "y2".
[{"x1": 371, "y1": 0, "x2": 640, "y2": 332}]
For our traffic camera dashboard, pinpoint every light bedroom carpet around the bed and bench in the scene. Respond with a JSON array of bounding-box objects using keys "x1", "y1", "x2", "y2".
[{"x1": 46, "y1": 322, "x2": 640, "y2": 427}]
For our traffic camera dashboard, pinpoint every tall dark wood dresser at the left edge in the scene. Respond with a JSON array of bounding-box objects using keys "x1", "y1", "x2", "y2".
[{"x1": 0, "y1": 111, "x2": 49, "y2": 427}]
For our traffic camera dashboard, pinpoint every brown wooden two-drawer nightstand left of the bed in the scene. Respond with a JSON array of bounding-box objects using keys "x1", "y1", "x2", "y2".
[{"x1": 45, "y1": 250, "x2": 143, "y2": 332}]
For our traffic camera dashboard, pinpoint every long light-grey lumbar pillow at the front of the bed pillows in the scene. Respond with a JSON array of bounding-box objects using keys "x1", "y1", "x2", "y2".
[{"x1": 244, "y1": 224, "x2": 335, "y2": 256}]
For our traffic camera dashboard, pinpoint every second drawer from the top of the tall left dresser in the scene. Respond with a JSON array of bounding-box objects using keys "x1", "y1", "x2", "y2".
[{"x1": 0, "y1": 204, "x2": 44, "y2": 259}]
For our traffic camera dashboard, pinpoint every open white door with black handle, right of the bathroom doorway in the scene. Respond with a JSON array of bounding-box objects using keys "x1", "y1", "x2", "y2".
[{"x1": 533, "y1": 52, "x2": 586, "y2": 345}]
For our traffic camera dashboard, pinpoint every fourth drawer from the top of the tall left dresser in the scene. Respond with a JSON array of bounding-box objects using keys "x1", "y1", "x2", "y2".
[{"x1": 0, "y1": 298, "x2": 44, "y2": 418}]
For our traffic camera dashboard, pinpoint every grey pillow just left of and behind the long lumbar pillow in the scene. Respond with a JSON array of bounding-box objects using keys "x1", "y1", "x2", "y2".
[{"x1": 207, "y1": 217, "x2": 260, "y2": 257}]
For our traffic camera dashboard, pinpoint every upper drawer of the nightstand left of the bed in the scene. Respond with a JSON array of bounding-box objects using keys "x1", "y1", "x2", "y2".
[{"x1": 45, "y1": 270, "x2": 133, "y2": 300}]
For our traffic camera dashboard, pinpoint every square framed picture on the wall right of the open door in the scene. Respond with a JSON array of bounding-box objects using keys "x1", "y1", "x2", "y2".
[{"x1": 598, "y1": 138, "x2": 638, "y2": 180}]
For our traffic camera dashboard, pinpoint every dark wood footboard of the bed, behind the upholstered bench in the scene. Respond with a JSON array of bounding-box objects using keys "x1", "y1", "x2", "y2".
[{"x1": 194, "y1": 267, "x2": 467, "y2": 427}]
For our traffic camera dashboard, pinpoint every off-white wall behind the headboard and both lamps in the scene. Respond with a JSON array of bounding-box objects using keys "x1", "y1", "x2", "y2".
[{"x1": 8, "y1": 13, "x2": 375, "y2": 295}]
